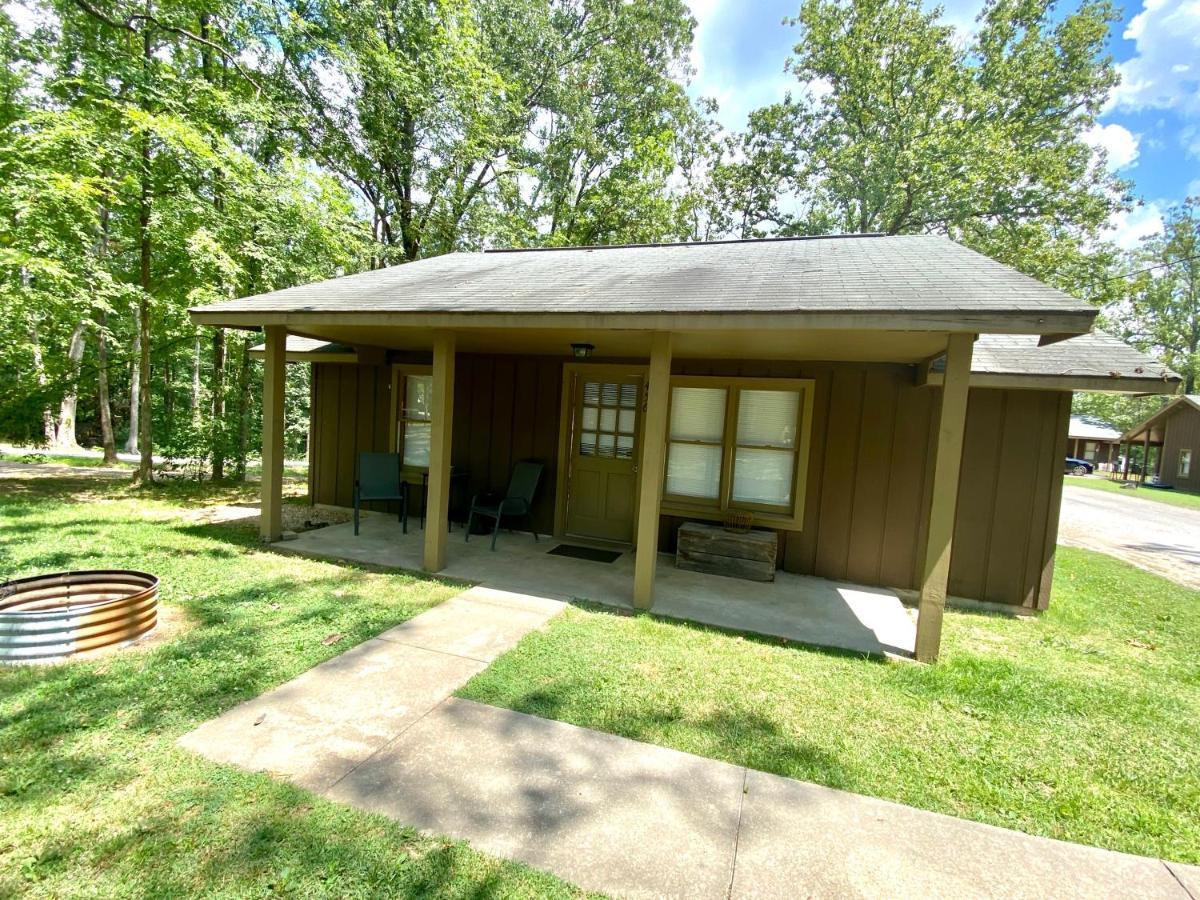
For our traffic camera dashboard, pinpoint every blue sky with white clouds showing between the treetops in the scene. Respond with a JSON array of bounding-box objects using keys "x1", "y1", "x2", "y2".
[{"x1": 689, "y1": 0, "x2": 1200, "y2": 246}]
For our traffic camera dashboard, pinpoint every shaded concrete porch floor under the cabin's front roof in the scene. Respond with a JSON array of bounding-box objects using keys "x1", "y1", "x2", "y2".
[{"x1": 283, "y1": 512, "x2": 917, "y2": 658}]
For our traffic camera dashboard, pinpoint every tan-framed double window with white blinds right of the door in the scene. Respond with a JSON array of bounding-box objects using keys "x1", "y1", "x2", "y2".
[{"x1": 664, "y1": 378, "x2": 811, "y2": 520}]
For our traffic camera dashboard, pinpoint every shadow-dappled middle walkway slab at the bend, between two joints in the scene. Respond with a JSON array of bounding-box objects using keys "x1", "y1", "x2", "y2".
[{"x1": 329, "y1": 698, "x2": 744, "y2": 899}]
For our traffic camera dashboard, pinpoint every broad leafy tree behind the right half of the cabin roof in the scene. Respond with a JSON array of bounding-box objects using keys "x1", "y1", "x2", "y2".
[{"x1": 716, "y1": 0, "x2": 1127, "y2": 287}]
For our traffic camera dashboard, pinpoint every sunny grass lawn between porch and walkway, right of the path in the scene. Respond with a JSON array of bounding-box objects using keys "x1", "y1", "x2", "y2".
[{"x1": 458, "y1": 550, "x2": 1200, "y2": 863}]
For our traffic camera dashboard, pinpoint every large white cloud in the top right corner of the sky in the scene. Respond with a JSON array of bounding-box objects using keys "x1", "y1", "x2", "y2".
[{"x1": 1110, "y1": 0, "x2": 1200, "y2": 115}]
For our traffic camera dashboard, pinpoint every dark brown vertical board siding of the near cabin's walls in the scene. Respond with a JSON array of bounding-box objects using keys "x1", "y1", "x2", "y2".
[{"x1": 312, "y1": 354, "x2": 1070, "y2": 610}]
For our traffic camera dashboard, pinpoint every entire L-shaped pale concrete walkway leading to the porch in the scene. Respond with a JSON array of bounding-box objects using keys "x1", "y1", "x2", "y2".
[{"x1": 180, "y1": 588, "x2": 1200, "y2": 900}]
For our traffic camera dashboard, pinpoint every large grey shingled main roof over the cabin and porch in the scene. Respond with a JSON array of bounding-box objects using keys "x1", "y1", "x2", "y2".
[{"x1": 193, "y1": 235, "x2": 1096, "y2": 334}]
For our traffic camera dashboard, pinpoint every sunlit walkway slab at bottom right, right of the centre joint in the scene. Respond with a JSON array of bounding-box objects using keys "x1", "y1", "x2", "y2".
[{"x1": 731, "y1": 770, "x2": 1184, "y2": 900}]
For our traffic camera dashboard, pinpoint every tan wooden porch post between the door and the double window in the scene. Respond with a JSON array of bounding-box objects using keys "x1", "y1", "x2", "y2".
[{"x1": 634, "y1": 331, "x2": 671, "y2": 610}]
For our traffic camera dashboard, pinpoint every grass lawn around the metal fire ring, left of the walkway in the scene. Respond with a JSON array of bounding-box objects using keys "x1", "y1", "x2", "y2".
[{"x1": 0, "y1": 478, "x2": 590, "y2": 898}]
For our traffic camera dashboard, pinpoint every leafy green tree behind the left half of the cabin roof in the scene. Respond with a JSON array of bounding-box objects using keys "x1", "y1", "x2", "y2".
[{"x1": 271, "y1": 0, "x2": 698, "y2": 264}]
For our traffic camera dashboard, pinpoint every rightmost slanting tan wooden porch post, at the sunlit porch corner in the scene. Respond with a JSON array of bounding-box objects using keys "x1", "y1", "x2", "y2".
[{"x1": 916, "y1": 334, "x2": 976, "y2": 662}]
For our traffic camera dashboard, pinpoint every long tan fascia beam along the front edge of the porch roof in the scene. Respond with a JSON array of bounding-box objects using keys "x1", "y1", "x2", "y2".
[{"x1": 188, "y1": 302, "x2": 1096, "y2": 335}]
